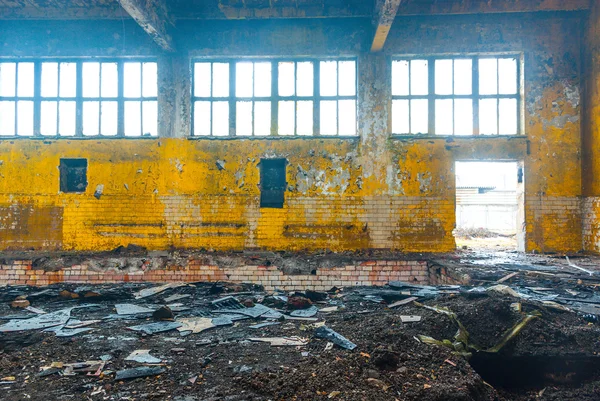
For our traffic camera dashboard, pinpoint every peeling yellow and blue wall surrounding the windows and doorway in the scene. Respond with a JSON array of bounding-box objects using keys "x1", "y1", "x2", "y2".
[{"x1": 0, "y1": 13, "x2": 582, "y2": 252}]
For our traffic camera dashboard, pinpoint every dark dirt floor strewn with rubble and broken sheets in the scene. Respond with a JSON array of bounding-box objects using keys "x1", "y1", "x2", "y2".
[{"x1": 0, "y1": 272, "x2": 600, "y2": 401}]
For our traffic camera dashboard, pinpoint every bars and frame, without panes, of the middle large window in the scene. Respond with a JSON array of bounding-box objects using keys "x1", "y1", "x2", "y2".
[{"x1": 191, "y1": 57, "x2": 358, "y2": 139}]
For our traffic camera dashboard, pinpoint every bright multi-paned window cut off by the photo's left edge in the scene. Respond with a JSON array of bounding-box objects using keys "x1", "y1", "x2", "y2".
[{"x1": 0, "y1": 60, "x2": 158, "y2": 137}]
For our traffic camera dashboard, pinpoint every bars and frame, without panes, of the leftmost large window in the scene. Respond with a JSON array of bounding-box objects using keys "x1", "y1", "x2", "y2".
[{"x1": 0, "y1": 57, "x2": 158, "y2": 139}]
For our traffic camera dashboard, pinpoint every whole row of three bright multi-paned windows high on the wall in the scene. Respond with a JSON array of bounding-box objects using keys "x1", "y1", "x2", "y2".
[{"x1": 0, "y1": 56, "x2": 521, "y2": 137}]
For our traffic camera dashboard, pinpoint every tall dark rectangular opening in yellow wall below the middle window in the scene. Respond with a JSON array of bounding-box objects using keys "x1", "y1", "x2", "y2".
[{"x1": 260, "y1": 159, "x2": 287, "y2": 209}]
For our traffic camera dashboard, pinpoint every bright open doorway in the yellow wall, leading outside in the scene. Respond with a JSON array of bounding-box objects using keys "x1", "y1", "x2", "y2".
[{"x1": 454, "y1": 161, "x2": 525, "y2": 252}]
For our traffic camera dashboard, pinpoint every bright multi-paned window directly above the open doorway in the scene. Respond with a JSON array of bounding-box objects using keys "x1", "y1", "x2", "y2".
[{"x1": 392, "y1": 56, "x2": 521, "y2": 135}]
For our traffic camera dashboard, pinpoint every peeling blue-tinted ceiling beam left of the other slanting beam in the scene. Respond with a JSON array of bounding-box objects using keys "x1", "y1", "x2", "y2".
[{"x1": 119, "y1": 0, "x2": 175, "y2": 52}]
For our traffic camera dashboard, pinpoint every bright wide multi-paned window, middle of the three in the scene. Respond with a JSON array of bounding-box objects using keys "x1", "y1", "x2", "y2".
[{"x1": 193, "y1": 59, "x2": 356, "y2": 137}]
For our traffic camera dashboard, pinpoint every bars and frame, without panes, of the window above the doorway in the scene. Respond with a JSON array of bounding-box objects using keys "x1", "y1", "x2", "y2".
[{"x1": 390, "y1": 53, "x2": 524, "y2": 137}]
